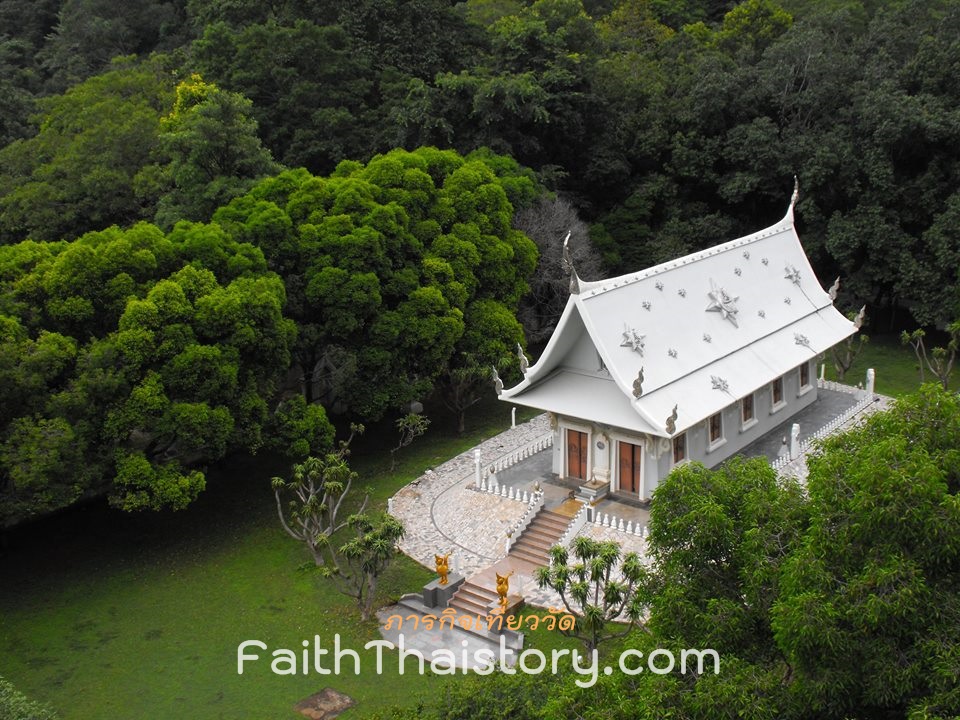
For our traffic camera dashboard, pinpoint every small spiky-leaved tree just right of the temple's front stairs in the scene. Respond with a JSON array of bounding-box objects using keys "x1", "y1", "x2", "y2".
[{"x1": 537, "y1": 535, "x2": 646, "y2": 652}]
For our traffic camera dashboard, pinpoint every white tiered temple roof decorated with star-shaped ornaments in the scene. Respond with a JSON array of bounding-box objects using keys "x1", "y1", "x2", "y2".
[{"x1": 501, "y1": 197, "x2": 856, "y2": 437}]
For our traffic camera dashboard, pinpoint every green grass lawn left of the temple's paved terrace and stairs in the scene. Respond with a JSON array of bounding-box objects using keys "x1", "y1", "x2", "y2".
[{"x1": 0, "y1": 401, "x2": 544, "y2": 720}]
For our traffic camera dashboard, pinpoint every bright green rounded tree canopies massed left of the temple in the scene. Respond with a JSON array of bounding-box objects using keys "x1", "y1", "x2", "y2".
[{"x1": 0, "y1": 146, "x2": 540, "y2": 525}]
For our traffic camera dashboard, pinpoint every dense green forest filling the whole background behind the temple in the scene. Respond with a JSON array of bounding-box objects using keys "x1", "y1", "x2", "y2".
[{"x1": 0, "y1": 0, "x2": 960, "y2": 525}]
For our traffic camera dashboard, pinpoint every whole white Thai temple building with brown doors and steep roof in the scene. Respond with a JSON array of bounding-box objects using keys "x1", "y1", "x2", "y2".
[{"x1": 500, "y1": 192, "x2": 862, "y2": 500}]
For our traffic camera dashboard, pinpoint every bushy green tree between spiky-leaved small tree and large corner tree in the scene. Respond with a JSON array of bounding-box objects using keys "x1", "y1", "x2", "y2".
[{"x1": 649, "y1": 457, "x2": 807, "y2": 660}]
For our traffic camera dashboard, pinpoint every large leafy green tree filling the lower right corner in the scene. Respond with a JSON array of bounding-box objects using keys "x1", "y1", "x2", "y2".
[{"x1": 771, "y1": 385, "x2": 960, "y2": 718}]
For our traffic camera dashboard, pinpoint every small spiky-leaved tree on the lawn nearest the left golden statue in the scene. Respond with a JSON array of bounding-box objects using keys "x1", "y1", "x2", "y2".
[{"x1": 322, "y1": 511, "x2": 405, "y2": 620}]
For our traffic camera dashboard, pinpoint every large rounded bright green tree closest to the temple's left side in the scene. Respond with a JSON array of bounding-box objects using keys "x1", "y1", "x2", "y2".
[{"x1": 214, "y1": 148, "x2": 538, "y2": 419}]
